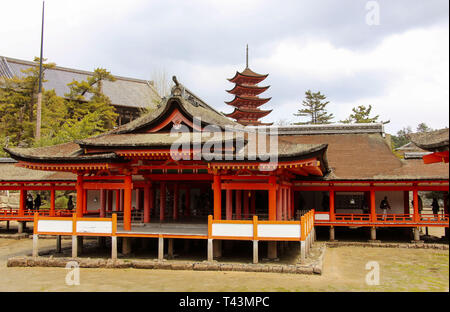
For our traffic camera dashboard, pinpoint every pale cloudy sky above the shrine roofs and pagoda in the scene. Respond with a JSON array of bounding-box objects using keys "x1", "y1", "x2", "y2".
[{"x1": 0, "y1": 0, "x2": 449, "y2": 134}]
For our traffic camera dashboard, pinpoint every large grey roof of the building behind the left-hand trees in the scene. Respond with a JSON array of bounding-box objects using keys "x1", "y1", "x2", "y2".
[{"x1": 0, "y1": 56, "x2": 161, "y2": 108}]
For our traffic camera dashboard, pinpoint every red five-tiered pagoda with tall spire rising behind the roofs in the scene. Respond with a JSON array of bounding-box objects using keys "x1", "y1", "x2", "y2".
[{"x1": 225, "y1": 44, "x2": 272, "y2": 126}]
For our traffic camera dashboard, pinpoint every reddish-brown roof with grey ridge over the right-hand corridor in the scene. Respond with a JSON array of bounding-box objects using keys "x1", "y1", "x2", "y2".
[{"x1": 272, "y1": 124, "x2": 449, "y2": 180}]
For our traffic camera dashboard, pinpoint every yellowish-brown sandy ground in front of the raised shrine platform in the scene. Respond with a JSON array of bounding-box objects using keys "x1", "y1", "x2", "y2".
[{"x1": 0, "y1": 239, "x2": 449, "y2": 292}]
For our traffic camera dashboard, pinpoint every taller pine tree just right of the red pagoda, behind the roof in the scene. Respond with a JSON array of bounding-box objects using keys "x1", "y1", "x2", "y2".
[{"x1": 294, "y1": 90, "x2": 334, "y2": 125}]
